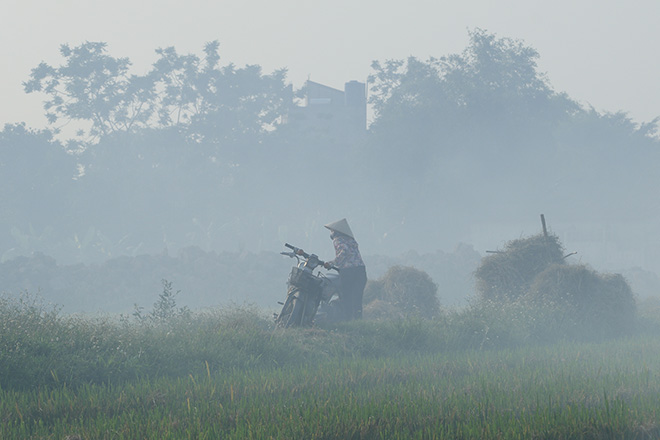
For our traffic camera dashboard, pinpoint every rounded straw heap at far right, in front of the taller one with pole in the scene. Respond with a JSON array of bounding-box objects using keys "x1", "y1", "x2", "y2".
[{"x1": 527, "y1": 264, "x2": 636, "y2": 339}]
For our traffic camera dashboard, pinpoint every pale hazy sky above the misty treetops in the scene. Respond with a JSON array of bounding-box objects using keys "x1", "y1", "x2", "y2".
[{"x1": 0, "y1": 0, "x2": 660, "y2": 128}]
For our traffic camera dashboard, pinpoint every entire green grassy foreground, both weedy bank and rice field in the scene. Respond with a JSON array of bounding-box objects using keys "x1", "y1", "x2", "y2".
[{"x1": 0, "y1": 290, "x2": 660, "y2": 440}]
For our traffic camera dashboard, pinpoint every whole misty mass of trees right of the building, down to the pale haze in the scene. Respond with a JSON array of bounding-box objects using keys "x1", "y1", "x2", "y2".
[{"x1": 360, "y1": 29, "x2": 660, "y2": 258}]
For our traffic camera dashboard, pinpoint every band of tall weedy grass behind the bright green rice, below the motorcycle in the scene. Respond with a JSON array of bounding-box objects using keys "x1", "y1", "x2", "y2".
[{"x1": 0, "y1": 289, "x2": 658, "y2": 389}]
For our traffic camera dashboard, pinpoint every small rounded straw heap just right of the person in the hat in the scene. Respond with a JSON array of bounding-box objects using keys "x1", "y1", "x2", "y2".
[{"x1": 364, "y1": 266, "x2": 440, "y2": 318}]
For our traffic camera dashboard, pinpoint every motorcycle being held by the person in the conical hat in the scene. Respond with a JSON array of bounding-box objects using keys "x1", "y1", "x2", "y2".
[{"x1": 275, "y1": 243, "x2": 341, "y2": 328}]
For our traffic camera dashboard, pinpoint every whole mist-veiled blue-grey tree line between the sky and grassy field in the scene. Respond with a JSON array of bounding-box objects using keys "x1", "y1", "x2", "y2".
[{"x1": 0, "y1": 29, "x2": 660, "y2": 312}]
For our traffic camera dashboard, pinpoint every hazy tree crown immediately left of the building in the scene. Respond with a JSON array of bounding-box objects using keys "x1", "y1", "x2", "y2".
[{"x1": 151, "y1": 41, "x2": 293, "y2": 144}]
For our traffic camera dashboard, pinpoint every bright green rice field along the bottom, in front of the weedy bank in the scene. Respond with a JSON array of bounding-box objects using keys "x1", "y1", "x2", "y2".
[{"x1": 0, "y1": 339, "x2": 660, "y2": 439}]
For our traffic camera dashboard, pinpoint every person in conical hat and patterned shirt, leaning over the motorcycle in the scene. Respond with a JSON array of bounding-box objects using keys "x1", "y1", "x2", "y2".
[{"x1": 325, "y1": 218, "x2": 367, "y2": 319}]
